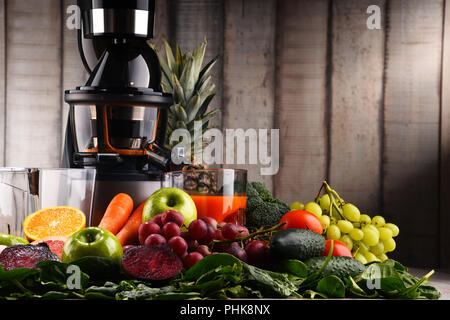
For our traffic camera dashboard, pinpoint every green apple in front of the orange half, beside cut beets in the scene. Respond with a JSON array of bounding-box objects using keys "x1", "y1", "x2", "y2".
[{"x1": 61, "y1": 227, "x2": 123, "y2": 265}]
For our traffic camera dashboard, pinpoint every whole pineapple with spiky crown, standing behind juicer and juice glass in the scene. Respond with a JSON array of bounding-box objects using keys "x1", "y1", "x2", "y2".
[{"x1": 151, "y1": 39, "x2": 219, "y2": 194}]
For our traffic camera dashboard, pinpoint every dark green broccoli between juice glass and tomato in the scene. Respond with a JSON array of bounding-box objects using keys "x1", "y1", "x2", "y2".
[{"x1": 246, "y1": 182, "x2": 290, "y2": 228}]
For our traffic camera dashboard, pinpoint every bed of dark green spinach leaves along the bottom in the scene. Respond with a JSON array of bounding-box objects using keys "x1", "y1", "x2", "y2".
[{"x1": 0, "y1": 250, "x2": 441, "y2": 300}]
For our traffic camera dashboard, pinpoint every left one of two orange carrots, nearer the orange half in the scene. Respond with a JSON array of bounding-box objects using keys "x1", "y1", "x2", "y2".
[{"x1": 98, "y1": 193, "x2": 133, "y2": 234}]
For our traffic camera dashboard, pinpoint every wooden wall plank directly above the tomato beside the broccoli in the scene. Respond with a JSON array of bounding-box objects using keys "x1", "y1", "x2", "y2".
[{"x1": 274, "y1": 0, "x2": 329, "y2": 212}]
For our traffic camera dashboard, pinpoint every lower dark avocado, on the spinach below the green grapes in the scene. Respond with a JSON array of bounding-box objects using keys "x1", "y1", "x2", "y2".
[{"x1": 305, "y1": 256, "x2": 366, "y2": 279}]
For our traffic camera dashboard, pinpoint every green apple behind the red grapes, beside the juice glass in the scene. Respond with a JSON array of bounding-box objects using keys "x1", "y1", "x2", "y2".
[{"x1": 142, "y1": 188, "x2": 197, "y2": 227}]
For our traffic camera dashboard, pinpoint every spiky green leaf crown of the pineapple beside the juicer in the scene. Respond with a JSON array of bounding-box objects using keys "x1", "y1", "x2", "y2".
[{"x1": 151, "y1": 39, "x2": 219, "y2": 148}]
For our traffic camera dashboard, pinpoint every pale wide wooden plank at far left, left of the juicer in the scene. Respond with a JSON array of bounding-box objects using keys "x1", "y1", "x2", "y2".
[{"x1": 4, "y1": 0, "x2": 62, "y2": 167}]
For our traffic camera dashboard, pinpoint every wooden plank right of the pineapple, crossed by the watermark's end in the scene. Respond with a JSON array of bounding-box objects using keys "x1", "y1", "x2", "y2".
[{"x1": 222, "y1": 0, "x2": 276, "y2": 189}]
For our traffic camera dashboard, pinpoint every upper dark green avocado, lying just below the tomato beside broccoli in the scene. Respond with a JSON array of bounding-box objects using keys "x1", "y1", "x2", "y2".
[{"x1": 270, "y1": 229, "x2": 325, "y2": 261}]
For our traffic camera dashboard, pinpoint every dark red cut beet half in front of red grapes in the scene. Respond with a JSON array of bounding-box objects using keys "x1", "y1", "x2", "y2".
[{"x1": 122, "y1": 244, "x2": 183, "y2": 280}]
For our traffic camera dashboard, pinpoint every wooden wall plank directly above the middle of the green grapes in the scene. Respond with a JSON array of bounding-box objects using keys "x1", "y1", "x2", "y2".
[{"x1": 329, "y1": 0, "x2": 385, "y2": 212}]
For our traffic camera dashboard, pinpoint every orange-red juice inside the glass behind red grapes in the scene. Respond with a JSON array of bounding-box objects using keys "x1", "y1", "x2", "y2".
[{"x1": 191, "y1": 195, "x2": 247, "y2": 224}]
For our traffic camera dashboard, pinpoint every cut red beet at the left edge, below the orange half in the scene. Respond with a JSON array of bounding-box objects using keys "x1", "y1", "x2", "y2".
[{"x1": 0, "y1": 242, "x2": 59, "y2": 270}]
